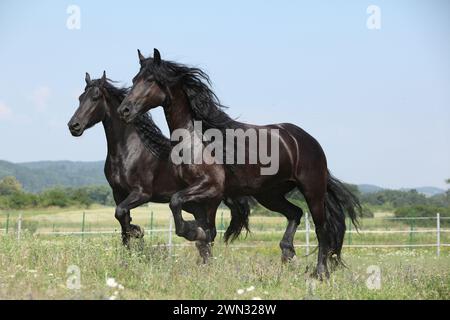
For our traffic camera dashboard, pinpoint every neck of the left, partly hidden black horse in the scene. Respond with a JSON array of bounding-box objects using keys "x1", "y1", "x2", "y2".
[{"x1": 103, "y1": 101, "x2": 136, "y2": 155}]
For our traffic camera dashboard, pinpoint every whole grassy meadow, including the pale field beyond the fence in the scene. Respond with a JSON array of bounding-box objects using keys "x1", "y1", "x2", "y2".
[{"x1": 0, "y1": 205, "x2": 450, "y2": 299}]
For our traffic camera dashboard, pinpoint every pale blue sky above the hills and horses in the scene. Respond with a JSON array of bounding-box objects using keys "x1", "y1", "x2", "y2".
[{"x1": 0, "y1": 0, "x2": 450, "y2": 188}]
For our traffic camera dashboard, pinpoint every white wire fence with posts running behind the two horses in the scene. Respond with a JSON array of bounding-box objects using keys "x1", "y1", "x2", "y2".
[{"x1": 0, "y1": 212, "x2": 450, "y2": 256}]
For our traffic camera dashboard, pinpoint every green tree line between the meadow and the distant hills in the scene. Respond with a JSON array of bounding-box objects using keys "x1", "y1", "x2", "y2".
[{"x1": 0, "y1": 176, "x2": 450, "y2": 217}]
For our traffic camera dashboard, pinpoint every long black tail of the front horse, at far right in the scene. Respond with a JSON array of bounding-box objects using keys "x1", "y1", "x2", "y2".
[{"x1": 325, "y1": 172, "x2": 362, "y2": 267}]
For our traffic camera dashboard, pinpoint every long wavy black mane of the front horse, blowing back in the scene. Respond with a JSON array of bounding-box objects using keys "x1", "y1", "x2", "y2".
[{"x1": 144, "y1": 58, "x2": 236, "y2": 131}]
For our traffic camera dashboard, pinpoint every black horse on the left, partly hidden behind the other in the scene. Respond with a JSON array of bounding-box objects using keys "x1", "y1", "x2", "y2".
[{"x1": 68, "y1": 73, "x2": 250, "y2": 260}]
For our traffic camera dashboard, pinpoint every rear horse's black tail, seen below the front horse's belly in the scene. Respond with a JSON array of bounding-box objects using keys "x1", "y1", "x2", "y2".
[{"x1": 223, "y1": 197, "x2": 253, "y2": 243}]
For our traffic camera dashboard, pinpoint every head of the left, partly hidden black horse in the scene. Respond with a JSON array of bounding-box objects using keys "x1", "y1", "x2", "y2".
[{"x1": 67, "y1": 71, "x2": 107, "y2": 137}]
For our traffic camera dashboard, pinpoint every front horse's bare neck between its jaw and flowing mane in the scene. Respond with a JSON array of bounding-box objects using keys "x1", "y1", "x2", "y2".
[{"x1": 164, "y1": 88, "x2": 194, "y2": 134}]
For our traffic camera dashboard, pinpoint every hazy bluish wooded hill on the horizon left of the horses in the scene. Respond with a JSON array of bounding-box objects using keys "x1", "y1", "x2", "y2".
[{"x1": 0, "y1": 160, "x2": 107, "y2": 192}]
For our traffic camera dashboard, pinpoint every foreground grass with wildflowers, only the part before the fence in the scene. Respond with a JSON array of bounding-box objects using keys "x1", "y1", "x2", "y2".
[{"x1": 0, "y1": 235, "x2": 450, "y2": 299}]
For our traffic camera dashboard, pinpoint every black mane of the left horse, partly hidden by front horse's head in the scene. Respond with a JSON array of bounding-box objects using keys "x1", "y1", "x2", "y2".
[{"x1": 96, "y1": 79, "x2": 171, "y2": 159}]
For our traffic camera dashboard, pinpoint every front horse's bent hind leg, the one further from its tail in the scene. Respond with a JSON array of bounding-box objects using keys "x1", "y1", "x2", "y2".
[{"x1": 255, "y1": 194, "x2": 303, "y2": 262}]
